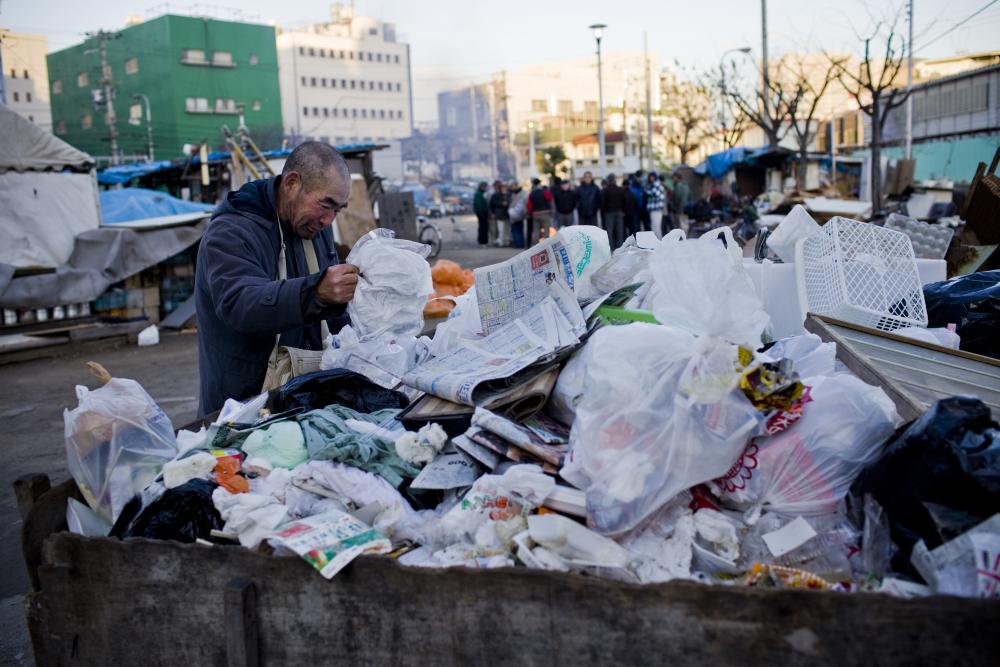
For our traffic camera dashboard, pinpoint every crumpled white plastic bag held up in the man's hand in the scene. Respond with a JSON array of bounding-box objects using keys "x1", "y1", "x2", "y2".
[{"x1": 347, "y1": 229, "x2": 434, "y2": 341}]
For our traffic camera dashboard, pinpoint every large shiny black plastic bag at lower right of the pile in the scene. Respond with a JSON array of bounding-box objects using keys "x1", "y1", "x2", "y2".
[{"x1": 855, "y1": 396, "x2": 1000, "y2": 574}]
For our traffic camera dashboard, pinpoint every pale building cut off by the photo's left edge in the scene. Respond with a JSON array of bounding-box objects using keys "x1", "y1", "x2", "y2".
[{"x1": 0, "y1": 28, "x2": 52, "y2": 132}]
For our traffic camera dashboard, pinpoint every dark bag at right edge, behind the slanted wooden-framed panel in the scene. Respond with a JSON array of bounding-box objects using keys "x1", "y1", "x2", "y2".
[{"x1": 924, "y1": 269, "x2": 1000, "y2": 359}]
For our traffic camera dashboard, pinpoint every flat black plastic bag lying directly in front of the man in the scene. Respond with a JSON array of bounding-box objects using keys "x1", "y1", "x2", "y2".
[{"x1": 267, "y1": 368, "x2": 410, "y2": 413}]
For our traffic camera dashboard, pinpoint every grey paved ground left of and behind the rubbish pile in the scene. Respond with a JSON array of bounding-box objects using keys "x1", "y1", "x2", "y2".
[{"x1": 0, "y1": 216, "x2": 516, "y2": 665}]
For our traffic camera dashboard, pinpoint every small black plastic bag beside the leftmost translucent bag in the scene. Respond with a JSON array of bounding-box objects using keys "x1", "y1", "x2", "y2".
[{"x1": 122, "y1": 479, "x2": 223, "y2": 542}]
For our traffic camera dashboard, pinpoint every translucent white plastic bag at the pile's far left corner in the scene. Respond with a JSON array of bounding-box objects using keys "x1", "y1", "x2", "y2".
[{"x1": 63, "y1": 378, "x2": 177, "y2": 524}]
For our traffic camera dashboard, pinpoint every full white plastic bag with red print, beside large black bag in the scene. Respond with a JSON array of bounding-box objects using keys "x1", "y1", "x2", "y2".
[{"x1": 715, "y1": 373, "x2": 899, "y2": 515}]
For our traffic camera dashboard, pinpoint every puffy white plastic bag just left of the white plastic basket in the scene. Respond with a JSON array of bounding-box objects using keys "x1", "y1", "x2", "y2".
[{"x1": 644, "y1": 227, "x2": 771, "y2": 349}]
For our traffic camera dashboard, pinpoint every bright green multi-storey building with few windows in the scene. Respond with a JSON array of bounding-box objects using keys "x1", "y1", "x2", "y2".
[{"x1": 48, "y1": 14, "x2": 282, "y2": 160}]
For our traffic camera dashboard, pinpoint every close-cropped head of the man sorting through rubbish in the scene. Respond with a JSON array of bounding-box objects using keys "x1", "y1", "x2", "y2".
[{"x1": 279, "y1": 141, "x2": 351, "y2": 238}]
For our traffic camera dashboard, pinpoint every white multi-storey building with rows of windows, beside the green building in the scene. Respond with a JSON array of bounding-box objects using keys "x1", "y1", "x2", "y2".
[{"x1": 277, "y1": 5, "x2": 413, "y2": 178}]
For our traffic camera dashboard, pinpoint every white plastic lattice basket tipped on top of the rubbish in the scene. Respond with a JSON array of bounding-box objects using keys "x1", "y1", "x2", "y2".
[{"x1": 795, "y1": 217, "x2": 927, "y2": 331}]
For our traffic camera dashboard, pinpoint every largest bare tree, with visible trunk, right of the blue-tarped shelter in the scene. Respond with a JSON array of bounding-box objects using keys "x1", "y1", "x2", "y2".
[{"x1": 827, "y1": 18, "x2": 909, "y2": 214}]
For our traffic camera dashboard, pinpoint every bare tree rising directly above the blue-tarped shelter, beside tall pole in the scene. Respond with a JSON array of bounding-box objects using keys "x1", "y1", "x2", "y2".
[{"x1": 716, "y1": 62, "x2": 801, "y2": 148}]
